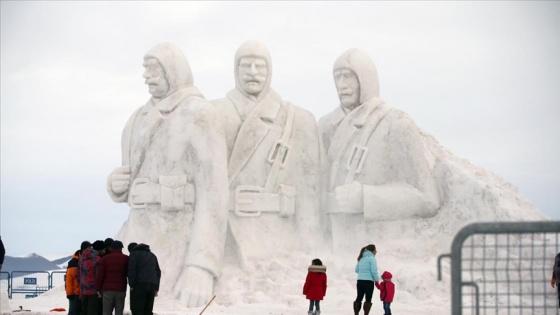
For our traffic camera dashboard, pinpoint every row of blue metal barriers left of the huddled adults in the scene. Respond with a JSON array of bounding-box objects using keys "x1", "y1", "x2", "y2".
[{"x1": 0, "y1": 271, "x2": 66, "y2": 299}]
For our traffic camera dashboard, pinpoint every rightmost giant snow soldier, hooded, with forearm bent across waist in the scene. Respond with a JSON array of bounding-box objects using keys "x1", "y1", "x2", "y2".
[{"x1": 318, "y1": 49, "x2": 440, "y2": 252}]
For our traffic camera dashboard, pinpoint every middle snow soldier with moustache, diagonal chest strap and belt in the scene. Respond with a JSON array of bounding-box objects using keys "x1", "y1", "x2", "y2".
[{"x1": 212, "y1": 41, "x2": 320, "y2": 270}]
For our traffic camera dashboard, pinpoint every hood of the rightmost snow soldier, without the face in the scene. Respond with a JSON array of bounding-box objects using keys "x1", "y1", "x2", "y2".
[{"x1": 333, "y1": 48, "x2": 379, "y2": 104}]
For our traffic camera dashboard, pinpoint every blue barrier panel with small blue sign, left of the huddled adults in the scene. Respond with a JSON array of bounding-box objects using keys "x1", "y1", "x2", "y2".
[{"x1": 11, "y1": 271, "x2": 50, "y2": 299}]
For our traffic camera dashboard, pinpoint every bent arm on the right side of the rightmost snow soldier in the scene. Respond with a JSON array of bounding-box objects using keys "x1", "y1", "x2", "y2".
[{"x1": 362, "y1": 113, "x2": 440, "y2": 220}]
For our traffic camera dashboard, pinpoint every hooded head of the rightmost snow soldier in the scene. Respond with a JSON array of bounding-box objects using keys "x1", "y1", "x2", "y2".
[{"x1": 333, "y1": 48, "x2": 379, "y2": 110}]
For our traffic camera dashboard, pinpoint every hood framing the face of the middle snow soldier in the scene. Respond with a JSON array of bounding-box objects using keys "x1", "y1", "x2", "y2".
[{"x1": 233, "y1": 40, "x2": 272, "y2": 100}]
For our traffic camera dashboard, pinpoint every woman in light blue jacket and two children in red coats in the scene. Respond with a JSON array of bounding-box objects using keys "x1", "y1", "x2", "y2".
[{"x1": 303, "y1": 244, "x2": 394, "y2": 315}]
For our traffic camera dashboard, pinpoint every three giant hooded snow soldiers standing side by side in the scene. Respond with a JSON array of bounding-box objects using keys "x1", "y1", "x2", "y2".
[{"x1": 107, "y1": 40, "x2": 440, "y2": 307}]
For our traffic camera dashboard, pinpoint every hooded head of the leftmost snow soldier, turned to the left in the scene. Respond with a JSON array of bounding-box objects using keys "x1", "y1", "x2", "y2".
[{"x1": 143, "y1": 43, "x2": 193, "y2": 99}]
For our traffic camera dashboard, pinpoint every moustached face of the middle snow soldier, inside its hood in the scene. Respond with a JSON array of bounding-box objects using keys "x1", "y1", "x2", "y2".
[{"x1": 238, "y1": 57, "x2": 268, "y2": 96}]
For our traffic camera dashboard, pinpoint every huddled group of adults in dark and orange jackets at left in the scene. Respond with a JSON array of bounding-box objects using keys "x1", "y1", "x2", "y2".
[{"x1": 66, "y1": 238, "x2": 161, "y2": 315}]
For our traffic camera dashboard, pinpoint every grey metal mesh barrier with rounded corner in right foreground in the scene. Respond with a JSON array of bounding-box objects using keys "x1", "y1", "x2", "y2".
[{"x1": 438, "y1": 221, "x2": 560, "y2": 315}]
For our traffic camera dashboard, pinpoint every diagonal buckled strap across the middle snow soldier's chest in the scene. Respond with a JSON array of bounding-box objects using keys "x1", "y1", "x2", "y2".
[{"x1": 264, "y1": 102, "x2": 295, "y2": 192}]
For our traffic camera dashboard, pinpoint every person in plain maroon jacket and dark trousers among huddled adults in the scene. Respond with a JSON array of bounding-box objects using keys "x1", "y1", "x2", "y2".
[{"x1": 95, "y1": 241, "x2": 128, "y2": 315}]
